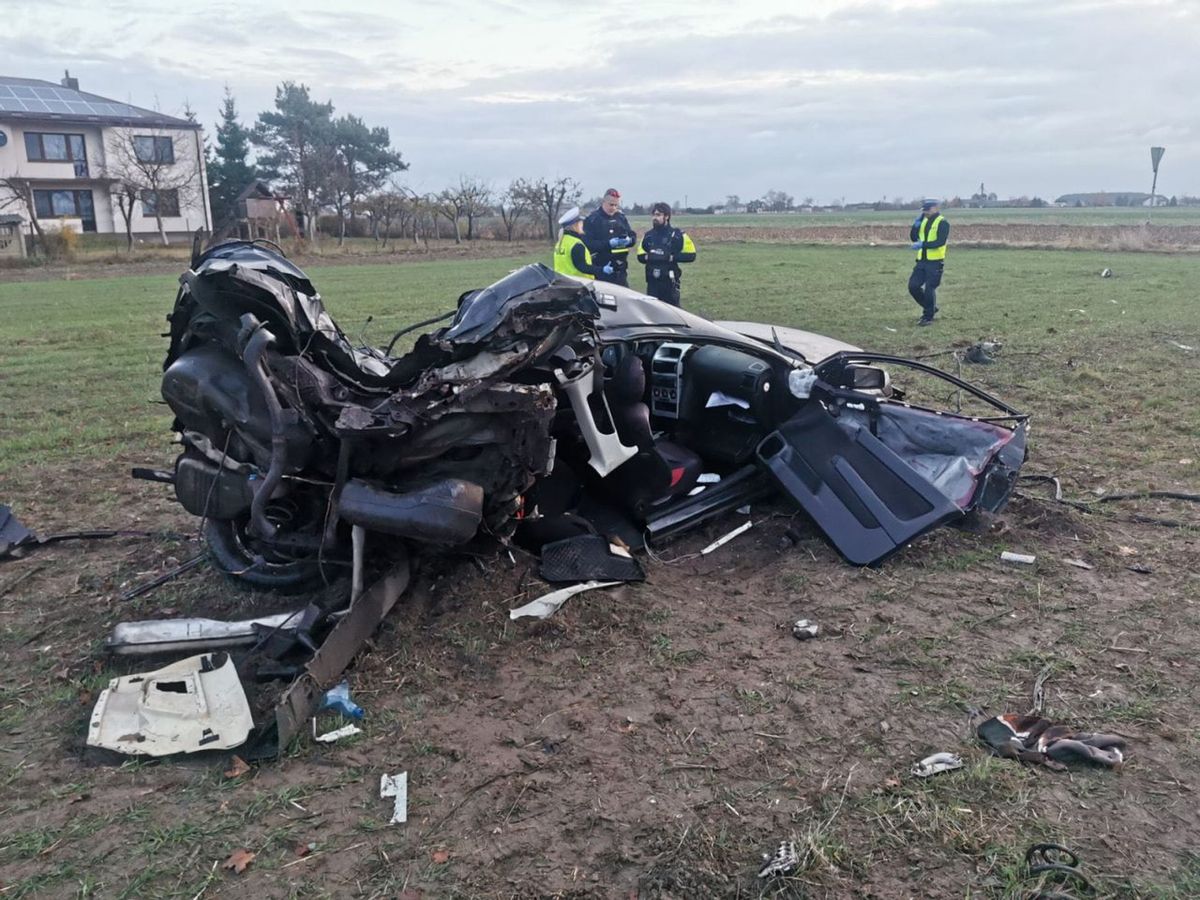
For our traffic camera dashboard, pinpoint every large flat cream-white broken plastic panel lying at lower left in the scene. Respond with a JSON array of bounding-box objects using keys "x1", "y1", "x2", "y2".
[{"x1": 88, "y1": 653, "x2": 254, "y2": 756}]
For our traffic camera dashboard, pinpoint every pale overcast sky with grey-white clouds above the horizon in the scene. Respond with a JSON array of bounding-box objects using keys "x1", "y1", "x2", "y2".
[{"x1": 0, "y1": 0, "x2": 1200, "y2": 205}]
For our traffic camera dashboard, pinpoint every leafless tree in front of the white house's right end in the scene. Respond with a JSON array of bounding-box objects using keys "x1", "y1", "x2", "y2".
[{"x1": 104, "y1": 128, "x2": 200, "y2": 246}]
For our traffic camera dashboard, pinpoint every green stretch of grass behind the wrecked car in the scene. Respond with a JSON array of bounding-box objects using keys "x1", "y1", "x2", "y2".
[{"x1": 0, "y1": 244, "x2": 1200, "y2": 489}]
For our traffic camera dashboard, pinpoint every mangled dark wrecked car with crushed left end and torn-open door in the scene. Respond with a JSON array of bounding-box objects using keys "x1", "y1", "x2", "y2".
[{"x1": 154, "y1": 241, "x2": 1027, "y2": 590}]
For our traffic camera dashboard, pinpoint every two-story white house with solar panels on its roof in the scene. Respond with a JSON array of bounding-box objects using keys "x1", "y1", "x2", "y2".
[{"x1": 0, "y1": 74, "x2": 212, "y2": 238}]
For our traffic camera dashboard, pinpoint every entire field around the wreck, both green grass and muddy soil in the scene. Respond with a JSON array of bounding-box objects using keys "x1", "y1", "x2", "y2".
[{"x1": 0, "y1": 244, "x2": 1200, "y2": 900}]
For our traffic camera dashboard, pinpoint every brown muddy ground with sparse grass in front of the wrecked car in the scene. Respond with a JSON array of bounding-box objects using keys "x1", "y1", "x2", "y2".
[{"x1": 0, "y1": 460, "x2": 1200, "y2": 898}]
